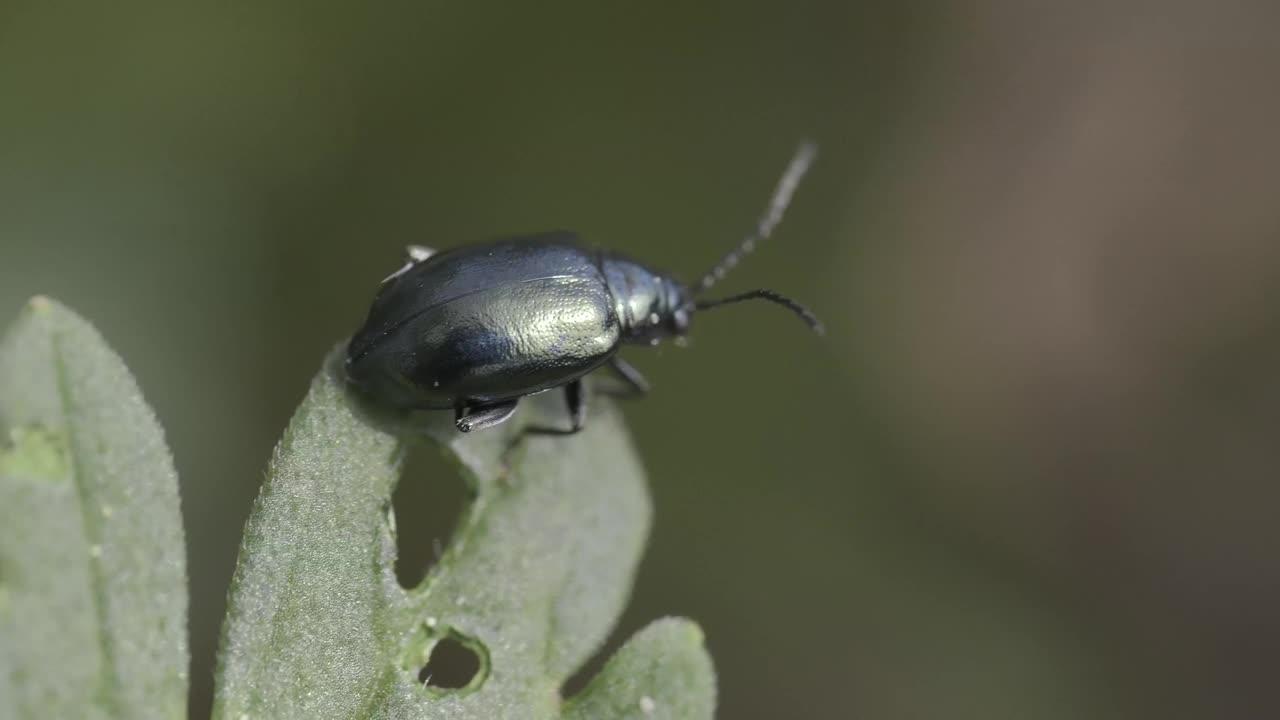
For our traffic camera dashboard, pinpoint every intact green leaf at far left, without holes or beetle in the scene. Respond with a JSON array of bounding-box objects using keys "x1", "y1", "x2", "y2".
[{"x1": 0, "y1": 297, "x2": 188, "y2": 720}]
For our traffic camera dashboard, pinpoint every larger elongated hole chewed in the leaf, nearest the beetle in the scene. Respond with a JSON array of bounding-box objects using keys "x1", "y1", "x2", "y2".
[{"x1": 392, "y1": 441, "x2": 471, "y2": 589}]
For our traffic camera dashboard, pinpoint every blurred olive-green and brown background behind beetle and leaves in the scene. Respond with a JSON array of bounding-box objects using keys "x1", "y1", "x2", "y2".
[{"x1": 0, "y1": 0, "x2": 1280, "y2": 720}]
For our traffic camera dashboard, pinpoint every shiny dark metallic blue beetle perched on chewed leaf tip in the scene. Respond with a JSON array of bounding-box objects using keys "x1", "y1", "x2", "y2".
[{"x1": 346, "y1": 142, "x2": 822, "y2": 434}]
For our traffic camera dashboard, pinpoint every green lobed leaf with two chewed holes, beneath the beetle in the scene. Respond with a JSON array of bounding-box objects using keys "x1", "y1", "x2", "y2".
[{"x1": 214, "y1": 352, "x2": 714, "y2": 720}]
